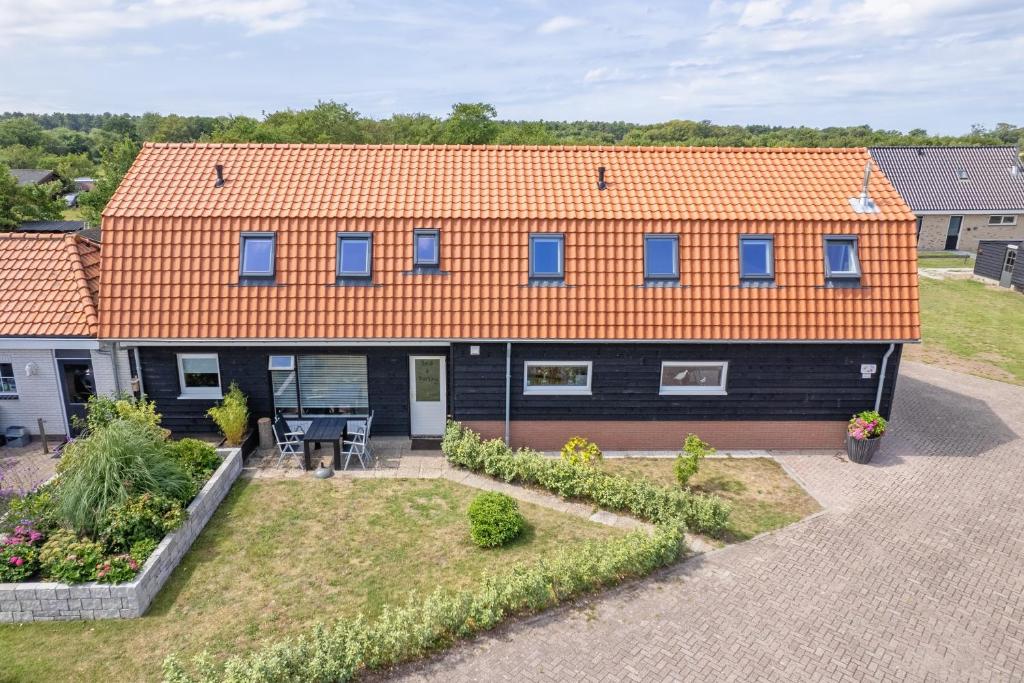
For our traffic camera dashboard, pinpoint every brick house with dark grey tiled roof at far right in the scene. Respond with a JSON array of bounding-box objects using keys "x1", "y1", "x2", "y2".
[{"x1": 870, "y1": 147, "x2": 1024, "y2": 252}]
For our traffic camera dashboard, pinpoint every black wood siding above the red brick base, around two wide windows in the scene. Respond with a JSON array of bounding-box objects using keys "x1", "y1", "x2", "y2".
[{"x1": 450, "y1": 343, "x2": 902, "y2": 420}]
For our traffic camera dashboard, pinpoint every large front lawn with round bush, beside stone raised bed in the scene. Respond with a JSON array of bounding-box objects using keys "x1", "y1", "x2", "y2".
[{"x1": 0, "y1": 477, "x2": 621, "y2": 681}]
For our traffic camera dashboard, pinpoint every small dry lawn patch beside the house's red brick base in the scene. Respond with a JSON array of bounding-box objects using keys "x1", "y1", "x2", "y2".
[{"x1": 601, "y1": 458, "x2": 821, "y2": 543}]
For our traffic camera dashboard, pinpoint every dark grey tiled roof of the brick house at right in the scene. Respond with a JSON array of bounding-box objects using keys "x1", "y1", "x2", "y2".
[{"x1": 870, "y1": 147, "x2": 1024, "y2": 212}]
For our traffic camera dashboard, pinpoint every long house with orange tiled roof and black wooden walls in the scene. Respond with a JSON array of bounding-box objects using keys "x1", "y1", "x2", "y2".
[{"x1": 100, "y1": 143, "x2": 921, "y2": 450}]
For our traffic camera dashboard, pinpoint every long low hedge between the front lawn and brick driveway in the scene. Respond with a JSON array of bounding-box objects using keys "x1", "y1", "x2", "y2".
[{"x1": 164, "y1": 524, "x2": 683, "y2": 683}]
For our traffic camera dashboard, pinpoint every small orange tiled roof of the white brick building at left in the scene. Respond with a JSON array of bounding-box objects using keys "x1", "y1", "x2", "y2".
[{"x1": 0, "y1": 233, "x2": 100, "y2": 337}]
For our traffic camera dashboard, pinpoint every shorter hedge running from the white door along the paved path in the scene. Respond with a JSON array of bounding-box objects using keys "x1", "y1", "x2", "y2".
[{"x1": 441, "y1": 422, "x2": 729, "y2": 536}]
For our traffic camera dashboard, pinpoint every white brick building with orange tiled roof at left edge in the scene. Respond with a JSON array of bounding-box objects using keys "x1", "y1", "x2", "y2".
[{"x1": 0, "y1": 233, "x2": 130, "y2": 435}]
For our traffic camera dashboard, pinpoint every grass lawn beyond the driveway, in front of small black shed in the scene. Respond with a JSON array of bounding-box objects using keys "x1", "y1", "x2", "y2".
[{"x1": 907, "y1": 278, "x2": 1024, "y2": 384}]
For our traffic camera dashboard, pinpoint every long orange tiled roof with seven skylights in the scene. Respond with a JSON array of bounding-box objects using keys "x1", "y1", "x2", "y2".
[{"x1": 100, "y1": 144, "x2": 920, "y2": 341}]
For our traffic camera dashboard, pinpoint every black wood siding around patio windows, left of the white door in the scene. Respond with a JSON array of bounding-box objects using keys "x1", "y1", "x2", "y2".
[{"x1": 139, "y1": 346, "x2": 452, "y2": 434}]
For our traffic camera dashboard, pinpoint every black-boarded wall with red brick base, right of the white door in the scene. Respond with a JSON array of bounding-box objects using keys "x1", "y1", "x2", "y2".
[{"x1": 450, "y1": 343, "x2": 902, "y2": 451}]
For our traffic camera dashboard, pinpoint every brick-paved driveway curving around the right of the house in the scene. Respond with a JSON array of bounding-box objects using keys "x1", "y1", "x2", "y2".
[{"x1": 399, "y1": 362, "x2": 1024, "y2": 681}]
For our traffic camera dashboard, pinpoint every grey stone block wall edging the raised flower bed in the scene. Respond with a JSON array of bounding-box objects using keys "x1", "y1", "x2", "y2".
[{"x1": 0, "y1": 449, "x2": 242, "y2": 624}]
